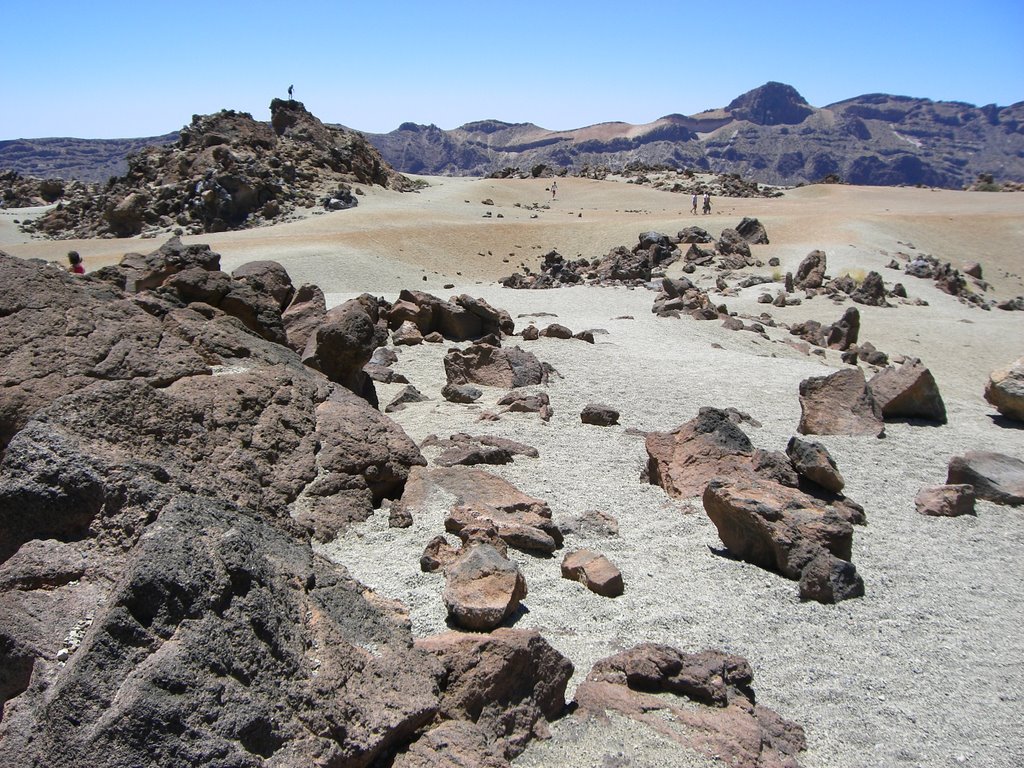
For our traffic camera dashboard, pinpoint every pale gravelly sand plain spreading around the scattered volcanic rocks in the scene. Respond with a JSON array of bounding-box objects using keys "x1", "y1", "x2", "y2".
[{"x1": 0, "y1": 178, "x2": 1024, "y2": 768}]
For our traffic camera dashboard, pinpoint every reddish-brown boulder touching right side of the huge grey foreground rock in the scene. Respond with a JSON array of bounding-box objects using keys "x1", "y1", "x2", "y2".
[{"x1": 415, "y1": 628, "x2": 572, "y2": 766}]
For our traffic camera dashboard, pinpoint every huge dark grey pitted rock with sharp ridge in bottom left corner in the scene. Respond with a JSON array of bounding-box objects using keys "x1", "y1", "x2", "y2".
[{"x1": 0, "y1": 493, "x2": 438, "y2": 768}]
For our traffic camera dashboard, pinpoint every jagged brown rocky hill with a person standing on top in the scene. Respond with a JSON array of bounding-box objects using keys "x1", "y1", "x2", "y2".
[{"x1": 17, "y1": 99, "x2": 414, "y2": 238}]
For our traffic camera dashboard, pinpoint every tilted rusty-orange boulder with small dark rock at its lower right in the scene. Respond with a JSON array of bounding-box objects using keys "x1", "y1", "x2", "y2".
[{"x1": 702, "y1": 477, "x2": 855, "y2": 599}]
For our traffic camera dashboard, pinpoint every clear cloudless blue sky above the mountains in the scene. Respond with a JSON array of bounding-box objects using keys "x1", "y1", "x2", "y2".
[{"x1": 0, "y1": 0, "x2": 1024, "y2": 139}]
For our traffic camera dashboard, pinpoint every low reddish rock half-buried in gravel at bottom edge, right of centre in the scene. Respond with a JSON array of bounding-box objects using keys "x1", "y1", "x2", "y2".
[{"x1": 574, "y1": 643, "x2": 806, "y2": 768}]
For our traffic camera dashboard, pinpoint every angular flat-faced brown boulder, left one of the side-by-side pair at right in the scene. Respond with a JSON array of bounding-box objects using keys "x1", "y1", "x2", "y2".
[{"x1": 797, "y1": 368, "x2": 886, "y2": 437}]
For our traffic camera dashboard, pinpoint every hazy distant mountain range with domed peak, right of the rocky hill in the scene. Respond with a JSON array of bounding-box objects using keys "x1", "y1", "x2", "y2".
[{"x1": 368, "y1": 83, "x2": 1024, "y2": 188}]
